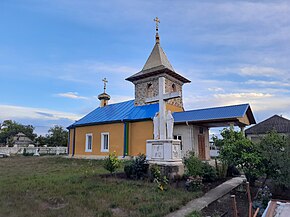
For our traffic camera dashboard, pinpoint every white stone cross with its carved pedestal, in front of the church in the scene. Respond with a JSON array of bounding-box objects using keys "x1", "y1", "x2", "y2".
[{"x1": 146, "y1": 77, "x2": 184, "y2": 178}]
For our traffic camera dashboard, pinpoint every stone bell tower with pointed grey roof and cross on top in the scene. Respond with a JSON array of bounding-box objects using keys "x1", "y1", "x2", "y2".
[{"x1": 126, "y1": 17, "x2": 190, "y2": 108}]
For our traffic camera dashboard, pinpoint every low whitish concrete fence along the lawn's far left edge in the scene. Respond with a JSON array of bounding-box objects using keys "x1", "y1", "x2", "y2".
[{"x1": 0, "y1": 147, "x2": 67, "y2": 155}]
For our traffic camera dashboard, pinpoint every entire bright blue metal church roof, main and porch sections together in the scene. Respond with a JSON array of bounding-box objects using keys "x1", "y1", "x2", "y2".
[{"x1": 68, "y1": 100, "x2": 255, "y2": 128}]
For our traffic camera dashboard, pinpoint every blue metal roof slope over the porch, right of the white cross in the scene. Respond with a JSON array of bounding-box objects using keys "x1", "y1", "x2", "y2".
[{"x1": 173, "y1": 104, "x2": 250, "y2": 123}]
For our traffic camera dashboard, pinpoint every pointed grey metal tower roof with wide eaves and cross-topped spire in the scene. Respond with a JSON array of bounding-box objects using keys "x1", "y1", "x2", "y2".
[{"x1": 126, "y1": 17, "x2": 190, "y2": 83}]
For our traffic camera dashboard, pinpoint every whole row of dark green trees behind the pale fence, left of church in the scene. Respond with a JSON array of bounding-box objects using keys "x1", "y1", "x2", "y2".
[{"x1": 0, "y1": 120, "x2": 68, "y2": 146}]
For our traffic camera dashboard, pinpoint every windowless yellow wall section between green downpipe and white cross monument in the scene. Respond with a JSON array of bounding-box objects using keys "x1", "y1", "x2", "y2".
[{"x1": 129, "y1": 120, "x2": 153, "y2": 156}]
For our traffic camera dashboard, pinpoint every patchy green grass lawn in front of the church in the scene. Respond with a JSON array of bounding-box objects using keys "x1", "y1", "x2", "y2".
[{"x1": 0, "y1": 156, "x2": 200, "y2": 217}]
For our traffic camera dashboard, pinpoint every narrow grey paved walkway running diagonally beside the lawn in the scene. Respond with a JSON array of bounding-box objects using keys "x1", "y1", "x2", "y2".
[{"x1": 166, "y1": 177, "x2": 245, "y2": 217}]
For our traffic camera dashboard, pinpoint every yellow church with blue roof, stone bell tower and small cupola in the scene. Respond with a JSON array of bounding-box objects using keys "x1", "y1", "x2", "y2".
[{"x1": 68, "y1": 19, "x2": 256, "y2": 160}]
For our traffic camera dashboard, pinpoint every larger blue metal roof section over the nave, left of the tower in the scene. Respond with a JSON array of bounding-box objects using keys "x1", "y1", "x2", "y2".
[{"x1": 69, "y1": 100, "x2": 158, "y2": 128}]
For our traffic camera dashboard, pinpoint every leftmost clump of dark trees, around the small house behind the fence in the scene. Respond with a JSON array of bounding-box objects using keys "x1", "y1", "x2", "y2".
[{"x1": 0, "y1": 120, "x2": 36, "y2": 145}]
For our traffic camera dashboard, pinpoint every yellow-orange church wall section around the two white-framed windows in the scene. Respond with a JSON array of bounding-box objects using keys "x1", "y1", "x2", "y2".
[{"x1": 75, "y1": 123, "x2": 124, "y2": 156}]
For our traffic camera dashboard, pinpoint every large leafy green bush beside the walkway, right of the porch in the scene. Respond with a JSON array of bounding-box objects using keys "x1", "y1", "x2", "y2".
[{"x1": 213, "y1": 127, "x2": 263, "y2": 182}]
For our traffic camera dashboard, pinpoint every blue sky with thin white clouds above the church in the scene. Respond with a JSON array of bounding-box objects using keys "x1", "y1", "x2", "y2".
[{"x1": 0, "y1": 0, "x2": 290, "y2": 134}]
